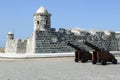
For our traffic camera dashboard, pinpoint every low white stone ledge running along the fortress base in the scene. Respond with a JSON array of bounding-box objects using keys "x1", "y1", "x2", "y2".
[{"x1": 0, "y1": 51, "x2": 120, "y2": 59}]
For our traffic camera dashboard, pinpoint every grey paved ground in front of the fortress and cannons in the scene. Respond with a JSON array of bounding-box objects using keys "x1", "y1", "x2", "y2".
[{"x1": 0, "y1": 57, "x2": 120, "y2": 80}]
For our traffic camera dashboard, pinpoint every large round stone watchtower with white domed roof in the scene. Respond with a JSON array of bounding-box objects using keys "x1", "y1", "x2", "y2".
[{"x1": 33, "y1": 7, "x2": 51, "y2": 31}]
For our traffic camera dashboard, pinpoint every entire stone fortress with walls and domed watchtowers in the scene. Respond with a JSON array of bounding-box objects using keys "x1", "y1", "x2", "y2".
[{"x1": 5, "y1": 7, "x2": 120, "y2": 54}]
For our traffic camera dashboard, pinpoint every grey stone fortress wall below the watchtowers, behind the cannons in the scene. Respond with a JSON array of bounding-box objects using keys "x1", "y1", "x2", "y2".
[{"x1": 5, "y1": 30, "x2": 120, "y2": 54}]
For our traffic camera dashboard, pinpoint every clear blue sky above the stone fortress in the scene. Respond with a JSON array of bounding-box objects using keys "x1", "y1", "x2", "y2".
[{"x1": 0, "y1": 0, "x2": 120, "y2": 47}]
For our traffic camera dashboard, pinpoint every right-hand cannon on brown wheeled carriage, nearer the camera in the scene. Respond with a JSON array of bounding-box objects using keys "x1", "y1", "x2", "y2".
[{"x1": 84, "y1": 41, "x2": 117, "y2": 65}]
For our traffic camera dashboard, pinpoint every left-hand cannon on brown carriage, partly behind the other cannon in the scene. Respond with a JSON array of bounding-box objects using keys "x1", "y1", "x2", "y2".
[{"x1": 67, "y1": 43, "x2": 92, "y2": 63}]
